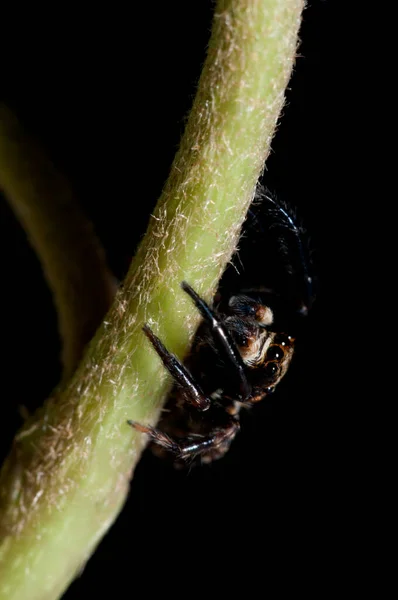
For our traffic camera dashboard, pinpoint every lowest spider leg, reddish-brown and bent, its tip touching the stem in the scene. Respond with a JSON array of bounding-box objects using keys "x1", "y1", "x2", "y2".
[{"x1": 127, "y1": 418, "x2": 239, "y2": 459}]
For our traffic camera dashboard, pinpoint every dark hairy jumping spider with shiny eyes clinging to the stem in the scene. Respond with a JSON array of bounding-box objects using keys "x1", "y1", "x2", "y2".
[{"x1": 128, "y1": 189, "x2": 314, "y2": 467}]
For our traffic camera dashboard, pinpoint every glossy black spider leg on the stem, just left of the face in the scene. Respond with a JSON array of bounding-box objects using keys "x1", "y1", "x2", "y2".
[{"x1": 181, "y1": 281, "x2": 251, "y2": 399}]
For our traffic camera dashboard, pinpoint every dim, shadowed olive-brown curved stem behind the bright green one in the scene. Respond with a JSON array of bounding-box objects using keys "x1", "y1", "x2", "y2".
[{"x1": 0, "y1": 104, "x2": 116, "y2": 381}]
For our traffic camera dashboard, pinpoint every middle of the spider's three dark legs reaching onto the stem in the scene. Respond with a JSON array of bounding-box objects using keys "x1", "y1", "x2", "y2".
[{"x1": 143, "y1": 325, "x2": 211, "y2": 411}]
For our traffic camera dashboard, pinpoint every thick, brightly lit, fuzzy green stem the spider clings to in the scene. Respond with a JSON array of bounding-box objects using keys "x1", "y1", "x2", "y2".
[{"x1": 0, "y1": 0, "x2": 303, "y2": 600}]
